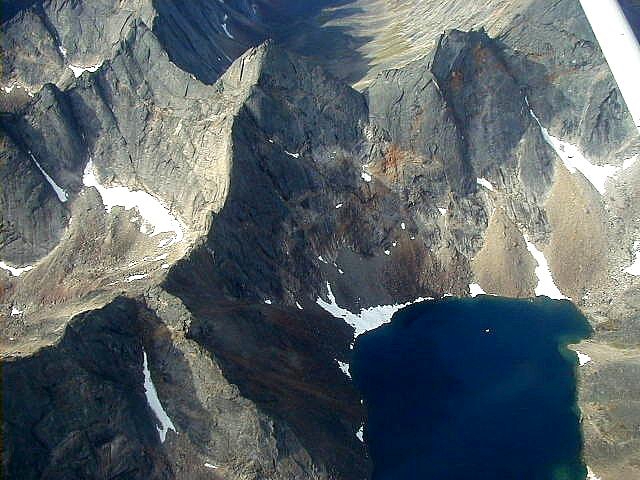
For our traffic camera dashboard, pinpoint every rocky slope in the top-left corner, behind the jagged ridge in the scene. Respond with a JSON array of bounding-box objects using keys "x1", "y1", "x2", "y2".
[{"x1": 2, "y1": 0, "x2": 153, "y2": 92}]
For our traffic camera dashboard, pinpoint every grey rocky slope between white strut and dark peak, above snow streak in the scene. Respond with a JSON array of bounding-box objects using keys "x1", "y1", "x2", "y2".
[{"x1": 499, "y1": 0, "x2": 637, "y2": 163}]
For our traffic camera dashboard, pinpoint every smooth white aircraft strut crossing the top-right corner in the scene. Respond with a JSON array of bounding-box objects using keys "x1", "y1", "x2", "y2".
[{"x1": 580, "y1": 0, "x2": 640, "y2": 128}]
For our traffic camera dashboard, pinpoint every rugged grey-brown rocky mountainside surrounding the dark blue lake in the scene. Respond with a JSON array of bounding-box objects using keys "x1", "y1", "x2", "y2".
[{"x1": 0, "y1": 0, "x2": 640, "y2": 479}]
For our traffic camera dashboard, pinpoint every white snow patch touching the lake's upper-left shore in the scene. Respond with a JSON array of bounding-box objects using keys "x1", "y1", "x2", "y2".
[{"x1": 316, "y1": 282, "x2": 431, "y2": 338}]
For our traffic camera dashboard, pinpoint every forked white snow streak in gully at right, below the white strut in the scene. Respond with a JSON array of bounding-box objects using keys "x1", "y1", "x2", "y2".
[{"x1": 527, "y1": 106, "x2": 620, "y2": 195}]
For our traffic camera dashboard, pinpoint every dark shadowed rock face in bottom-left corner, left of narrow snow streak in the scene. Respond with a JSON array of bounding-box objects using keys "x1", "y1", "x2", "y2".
[{"x1": 3, "y1": 299, "x2": 172, "y2": 479}]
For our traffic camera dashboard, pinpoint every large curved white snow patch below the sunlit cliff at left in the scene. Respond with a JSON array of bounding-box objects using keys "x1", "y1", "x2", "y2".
[{"x1": 82, "y1": 160, "x2": 184, "y2": 248}]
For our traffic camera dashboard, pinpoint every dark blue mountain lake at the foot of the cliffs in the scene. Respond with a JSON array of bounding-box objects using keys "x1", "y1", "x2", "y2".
[{"x1": 351, "y1": 296, "x2": 590, "y2": 480}]
